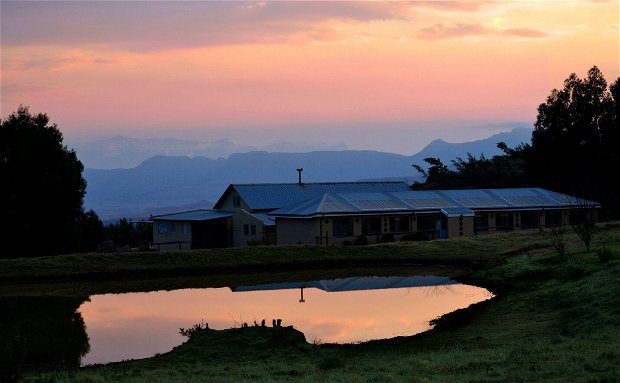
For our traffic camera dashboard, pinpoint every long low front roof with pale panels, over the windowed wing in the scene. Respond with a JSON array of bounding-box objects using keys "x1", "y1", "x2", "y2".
[{"x1": 269, "y1": 188, "x2": 600, "y2": 217}]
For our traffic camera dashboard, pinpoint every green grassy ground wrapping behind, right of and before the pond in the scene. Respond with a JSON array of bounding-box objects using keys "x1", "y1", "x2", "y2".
[{"x1": 10, "y1": 226, "x2": 620, "y2": 382}]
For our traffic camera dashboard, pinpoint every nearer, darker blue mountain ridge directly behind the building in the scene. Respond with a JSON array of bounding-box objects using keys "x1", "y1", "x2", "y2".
[{"x1": 84, "y1": 128, "x2": 532, "y2": 219}]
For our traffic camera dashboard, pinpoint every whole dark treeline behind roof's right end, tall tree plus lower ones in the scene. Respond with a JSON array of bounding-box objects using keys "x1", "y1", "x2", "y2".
[{"x1": 412, "y1": 66, "x2": 620, "y2": 218}]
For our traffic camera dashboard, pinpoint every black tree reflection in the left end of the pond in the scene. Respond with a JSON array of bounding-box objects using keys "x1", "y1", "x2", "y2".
[{"x1": 0, "y1": 297, "x2": 90, "y2": 381}]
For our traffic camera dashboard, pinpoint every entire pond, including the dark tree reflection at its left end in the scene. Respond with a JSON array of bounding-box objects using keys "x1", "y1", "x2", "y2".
[{"x1": 0, "y1": 275, "x2": 493, "y2": 366}]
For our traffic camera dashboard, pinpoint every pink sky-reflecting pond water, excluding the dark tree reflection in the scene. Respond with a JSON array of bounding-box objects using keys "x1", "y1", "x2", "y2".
[{"x1": 77, "y1": 276, "x2": 492, "y2": 365}]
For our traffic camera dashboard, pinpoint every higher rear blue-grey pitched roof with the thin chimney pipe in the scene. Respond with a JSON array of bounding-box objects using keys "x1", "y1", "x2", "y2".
[{"x1": 214, "y1": 181, "x2": 410, "y2": 210}]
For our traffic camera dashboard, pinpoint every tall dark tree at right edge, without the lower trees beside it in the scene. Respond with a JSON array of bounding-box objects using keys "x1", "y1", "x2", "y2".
[{"x1": 527, "y1": 66, "x2": 620, "y2": 216}]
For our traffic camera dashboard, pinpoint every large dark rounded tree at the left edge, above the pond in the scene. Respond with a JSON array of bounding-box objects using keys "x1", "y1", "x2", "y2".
[{"x1": 0, "y1": 106, "x2": 86, "y2": 258}]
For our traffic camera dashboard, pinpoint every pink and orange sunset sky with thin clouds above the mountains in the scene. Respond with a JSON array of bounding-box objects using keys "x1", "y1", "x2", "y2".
[{"x1": 0, "y1": 0, "x2": 620, "y2": 154}]
